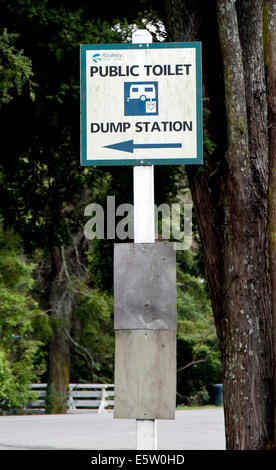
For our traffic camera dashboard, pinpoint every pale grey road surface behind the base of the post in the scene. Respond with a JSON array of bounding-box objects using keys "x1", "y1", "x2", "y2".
[{"x1": 0, "y1": 408, "x2": 225, "y2": 450}]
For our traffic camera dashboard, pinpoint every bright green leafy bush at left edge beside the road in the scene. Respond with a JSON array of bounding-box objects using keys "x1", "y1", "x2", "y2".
[{"x1": 0, "y1": 227, "x2": 47, "y2": 412}]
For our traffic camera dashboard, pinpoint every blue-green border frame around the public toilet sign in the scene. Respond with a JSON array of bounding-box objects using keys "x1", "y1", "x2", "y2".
[{"x1": 80, "y1": 42, "x2": 203, "y2": 166}]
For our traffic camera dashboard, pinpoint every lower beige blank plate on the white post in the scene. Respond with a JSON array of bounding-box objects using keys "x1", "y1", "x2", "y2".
[{"x1": 114, "y1": 330, "x2": 176, "y2": 419}]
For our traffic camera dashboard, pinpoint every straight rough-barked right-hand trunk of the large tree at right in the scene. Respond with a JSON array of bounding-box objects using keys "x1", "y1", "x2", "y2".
[{"x1": 217, "y1": 0, "x2": 273, "y2": 449}]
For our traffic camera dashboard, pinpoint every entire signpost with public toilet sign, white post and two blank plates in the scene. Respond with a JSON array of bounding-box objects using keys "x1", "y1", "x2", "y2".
[{"x1": 81, "y1": 30, "x2": 202, "y2": 450}]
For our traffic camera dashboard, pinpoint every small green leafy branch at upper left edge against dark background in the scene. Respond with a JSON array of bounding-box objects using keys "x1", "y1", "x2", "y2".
[{"x1": 0, "y1": 28, "x2": 35, "y2": 104}]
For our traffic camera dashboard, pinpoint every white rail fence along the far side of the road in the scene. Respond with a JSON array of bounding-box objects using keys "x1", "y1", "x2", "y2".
[{"x1": 29, "y1": 384, "x2": 114, "y2": 413}]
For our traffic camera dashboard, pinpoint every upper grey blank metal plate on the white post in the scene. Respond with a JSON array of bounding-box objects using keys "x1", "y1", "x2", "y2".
[{"x1": 114, "y1": 242, "x2": 176, "y2": 330}]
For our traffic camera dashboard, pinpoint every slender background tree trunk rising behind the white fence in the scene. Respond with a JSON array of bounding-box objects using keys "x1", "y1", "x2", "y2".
[{"x1": 48, "y1": 232, "x2": 88, "y2": 413}]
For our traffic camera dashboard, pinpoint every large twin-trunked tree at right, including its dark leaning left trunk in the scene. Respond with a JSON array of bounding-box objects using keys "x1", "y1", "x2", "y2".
[{"x1": 164, "y1": 0, "x2": 273, "y2": 449}]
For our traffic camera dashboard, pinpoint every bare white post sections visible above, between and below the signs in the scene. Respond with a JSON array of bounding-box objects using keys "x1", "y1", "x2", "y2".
[{"x1": 132, "y1": 29, "x2": 157, "y2": 450}]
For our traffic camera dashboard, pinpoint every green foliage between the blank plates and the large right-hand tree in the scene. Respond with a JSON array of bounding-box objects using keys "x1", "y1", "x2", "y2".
[{"x1": 177, "y1": 250, "x2": 222, "y2": 405}]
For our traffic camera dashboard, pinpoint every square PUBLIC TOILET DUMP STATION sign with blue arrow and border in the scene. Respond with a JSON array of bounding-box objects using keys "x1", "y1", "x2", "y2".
[{"x1": 81, "y1": 42, "x2": 202, "y2": 166}]
